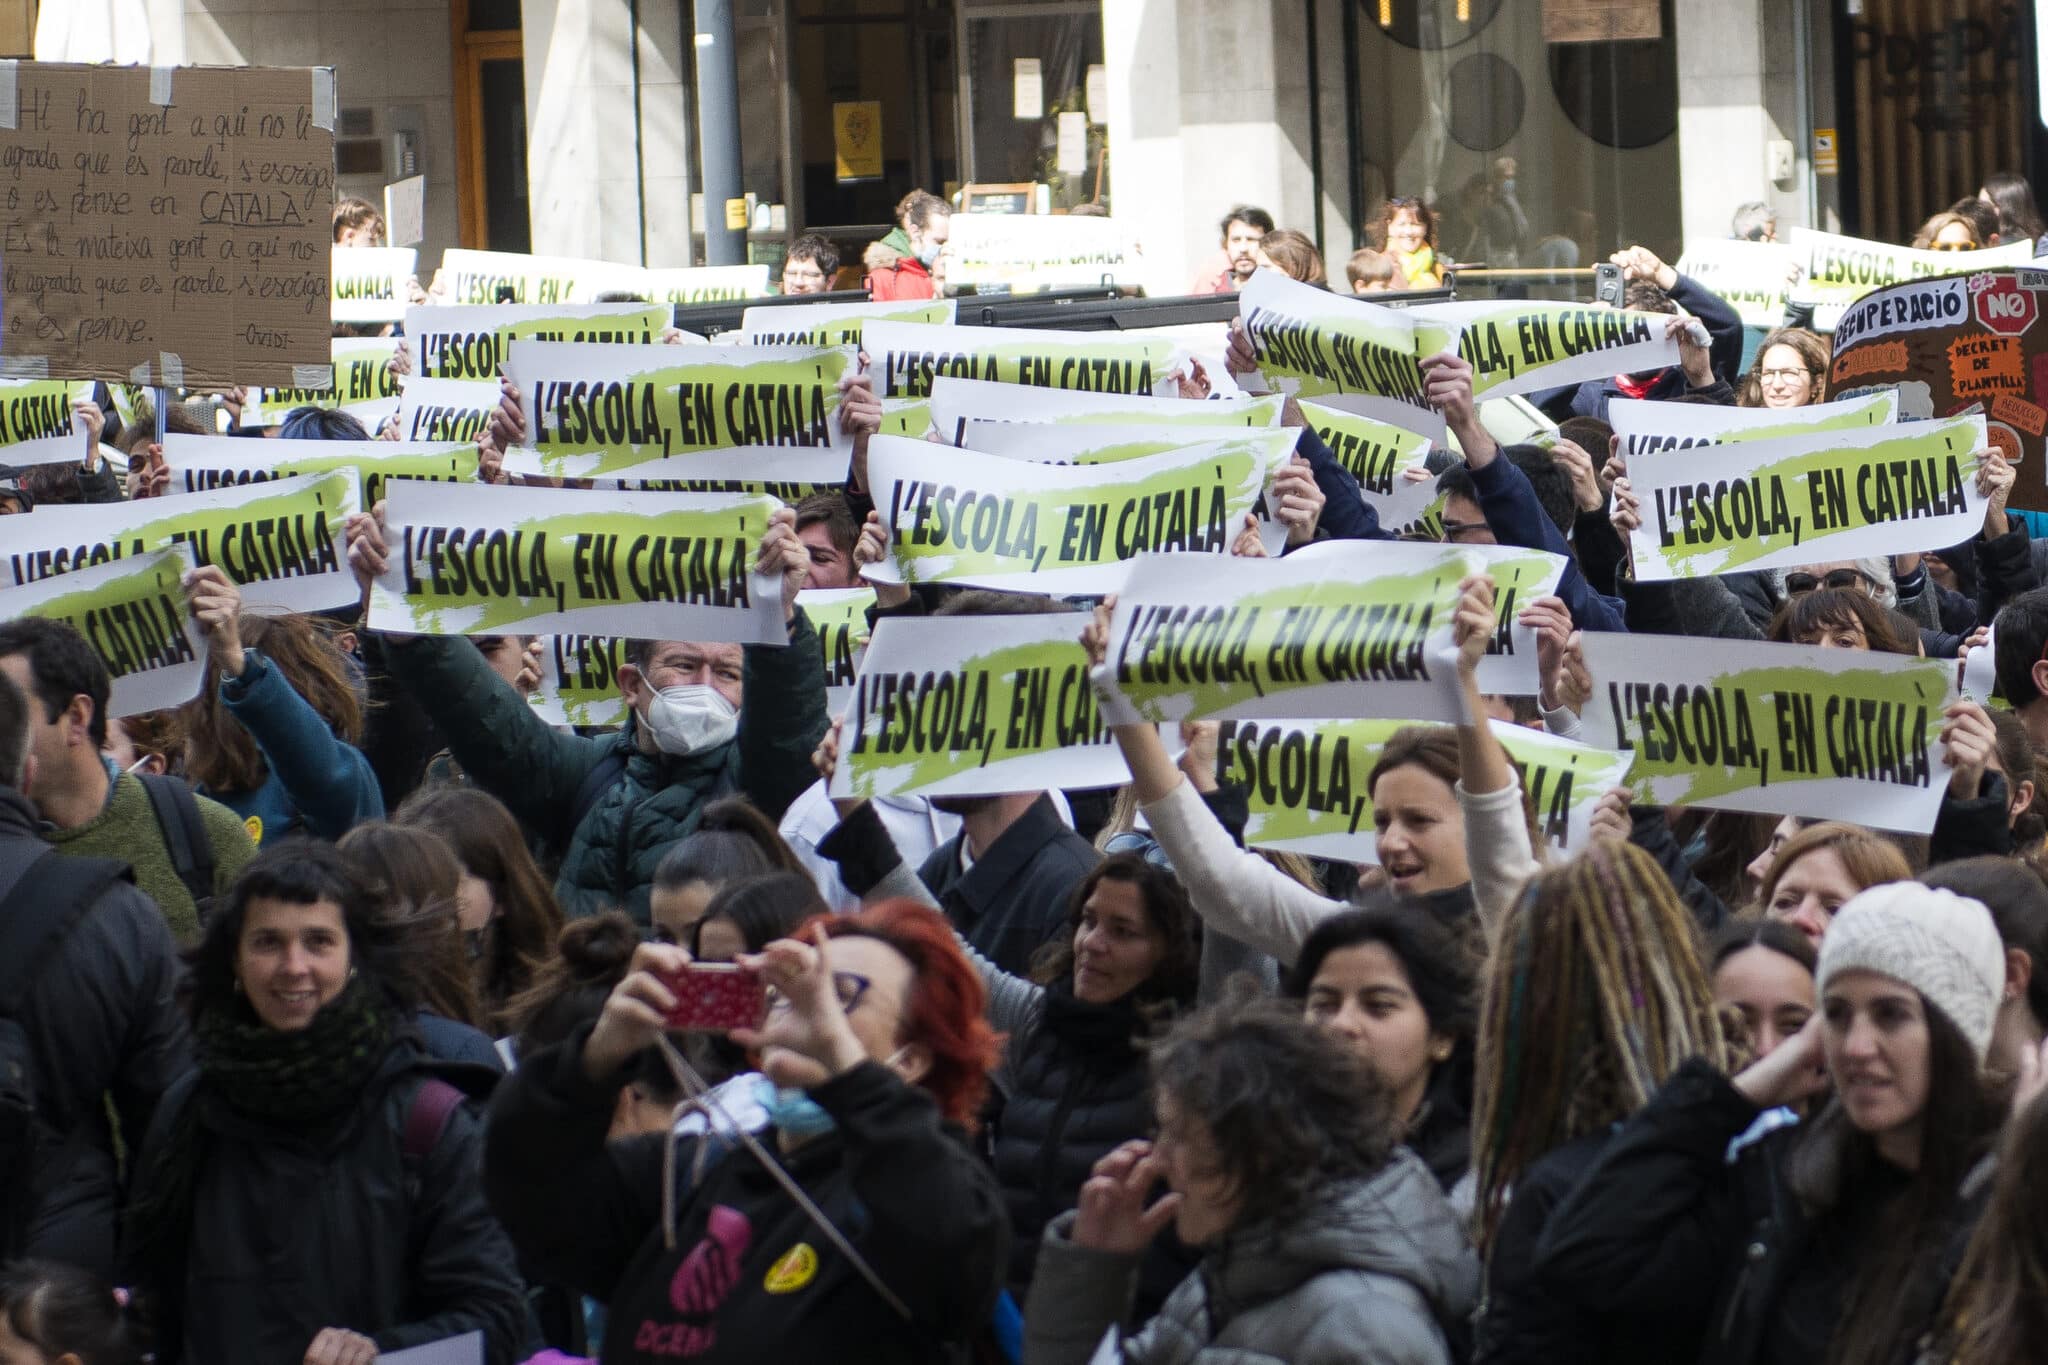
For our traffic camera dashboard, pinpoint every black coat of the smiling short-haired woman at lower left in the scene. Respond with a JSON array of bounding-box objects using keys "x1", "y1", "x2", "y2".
[{"x1": 139, "y1": 1036, "x2": 526, "y2": 1365}]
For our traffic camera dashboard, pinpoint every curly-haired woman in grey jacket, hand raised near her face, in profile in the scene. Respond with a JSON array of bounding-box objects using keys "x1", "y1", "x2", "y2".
[{"x1": 1024, "y1": 999, "x2": 1479, "y2": 1365}]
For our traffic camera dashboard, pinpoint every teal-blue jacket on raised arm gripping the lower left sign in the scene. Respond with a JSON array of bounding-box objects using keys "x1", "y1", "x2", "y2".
[{"x1": 207, "y1": 649, "x2": 383, "y2": 845}]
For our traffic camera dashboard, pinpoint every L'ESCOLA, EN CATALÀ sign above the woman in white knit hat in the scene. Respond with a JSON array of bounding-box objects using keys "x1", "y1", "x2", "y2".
[{"x1": 1581, "y1": 632, "x2": 1956, "y2": 833}]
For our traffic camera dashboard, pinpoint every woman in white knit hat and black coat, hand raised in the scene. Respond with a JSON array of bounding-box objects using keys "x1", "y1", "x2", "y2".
[{"x1": 1538, "y1": 882, "x2": 2005, "y2": 1365}]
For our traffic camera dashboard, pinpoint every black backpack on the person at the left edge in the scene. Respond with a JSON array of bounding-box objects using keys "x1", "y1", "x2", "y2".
[{"x1": 0, "y1": 849, "x2": 129, "y2": 1261}]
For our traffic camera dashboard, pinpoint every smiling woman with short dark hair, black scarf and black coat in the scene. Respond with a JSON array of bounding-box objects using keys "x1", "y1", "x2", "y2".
[{"x1": 129, "y1": 839, "x2": 526, "y2": 1365}]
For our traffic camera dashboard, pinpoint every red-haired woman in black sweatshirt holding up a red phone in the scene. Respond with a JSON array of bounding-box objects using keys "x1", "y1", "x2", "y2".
[{"x1": 483, "y1": 900, "x2": 1010, "y2": 1365}]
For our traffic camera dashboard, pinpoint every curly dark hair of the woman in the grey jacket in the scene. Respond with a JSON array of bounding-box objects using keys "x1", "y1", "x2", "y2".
[{"x1": 1151, "y1": 988, "x2": 1401, "y2": 1220}]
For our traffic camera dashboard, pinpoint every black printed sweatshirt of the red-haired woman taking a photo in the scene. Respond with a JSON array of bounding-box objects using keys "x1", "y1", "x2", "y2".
[{"x1": 485, "y1": 1029, "x2": 1010, "y2": 1365}]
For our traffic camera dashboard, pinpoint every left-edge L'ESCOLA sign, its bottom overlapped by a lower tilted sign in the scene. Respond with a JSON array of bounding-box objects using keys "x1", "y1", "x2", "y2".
[{"x1": 0, "y1": 471, "x2": 360, "y2": 612}]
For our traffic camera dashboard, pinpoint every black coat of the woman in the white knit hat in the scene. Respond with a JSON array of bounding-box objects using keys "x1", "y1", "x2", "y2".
[{"x1": 1536, "y1": 1060, "x2": 1982, "y2": 1365}]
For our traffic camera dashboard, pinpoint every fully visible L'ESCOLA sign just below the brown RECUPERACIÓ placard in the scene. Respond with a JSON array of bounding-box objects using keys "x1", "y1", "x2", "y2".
[{"x1": 1628, "y1": 417, "x2": 1985, "y2": 583}]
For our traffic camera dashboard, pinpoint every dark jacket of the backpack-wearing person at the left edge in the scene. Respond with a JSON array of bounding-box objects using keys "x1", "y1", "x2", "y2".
[{"x1": 0, "y1": 786, "x2": 193, "y2": 1277}]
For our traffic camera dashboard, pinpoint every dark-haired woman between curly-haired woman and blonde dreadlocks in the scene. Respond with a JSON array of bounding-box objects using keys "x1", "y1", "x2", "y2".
[{"x1": 1282, "y1": 909, "x2": 1479, "y2": 1209}]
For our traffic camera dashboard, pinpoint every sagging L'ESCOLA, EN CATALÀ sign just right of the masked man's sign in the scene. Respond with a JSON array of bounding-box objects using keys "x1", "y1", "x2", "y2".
[{"x1": 866, "y1": 432, "x2": 1292, "y2": 593}]
